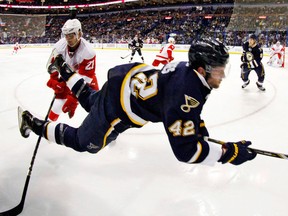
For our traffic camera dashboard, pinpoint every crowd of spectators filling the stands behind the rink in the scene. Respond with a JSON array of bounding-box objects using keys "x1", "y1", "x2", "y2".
[{"x1": 0, "y1": 0, "x2": 288, "y2": 47}]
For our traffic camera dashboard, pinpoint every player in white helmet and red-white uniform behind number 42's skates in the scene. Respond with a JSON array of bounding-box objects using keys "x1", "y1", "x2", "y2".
[{"x1": 47, "y1": 19, "x2": 99, "y2": 121}]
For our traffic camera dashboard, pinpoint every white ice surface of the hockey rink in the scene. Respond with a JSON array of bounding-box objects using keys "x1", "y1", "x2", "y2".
[{"x1": 0, "y1": 48, "x2": 288, "y2": 216}]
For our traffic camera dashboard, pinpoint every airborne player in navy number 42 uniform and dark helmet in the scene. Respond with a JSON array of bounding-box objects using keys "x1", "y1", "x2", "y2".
[{"x1": 20, "y1": 39, "x2": 256, "y2": 165}]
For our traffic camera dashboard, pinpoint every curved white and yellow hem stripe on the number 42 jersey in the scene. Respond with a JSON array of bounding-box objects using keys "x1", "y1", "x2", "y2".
[{"x1": 120, "y1": 64, "x2": 154, "y2": 126}]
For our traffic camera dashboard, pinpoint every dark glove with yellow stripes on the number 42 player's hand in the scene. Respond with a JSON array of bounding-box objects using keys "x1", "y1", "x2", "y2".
[{"x1": 218, "y1": 140, "x2": 257, "y2": 165}]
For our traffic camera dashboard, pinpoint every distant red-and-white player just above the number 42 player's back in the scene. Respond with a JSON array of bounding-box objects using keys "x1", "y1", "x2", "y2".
[{"x1": 152, "y1": 37, "x2": 175, "y2": 67}]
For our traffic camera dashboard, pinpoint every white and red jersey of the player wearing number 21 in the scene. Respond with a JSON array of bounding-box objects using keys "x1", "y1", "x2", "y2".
[{"x1": 55, "y1": 37, "x2": 96, "y2": 83}]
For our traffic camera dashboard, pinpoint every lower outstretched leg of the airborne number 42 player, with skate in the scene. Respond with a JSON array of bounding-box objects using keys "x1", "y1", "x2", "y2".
[{"x1": 19, "y1": 95, "x2": 130, "y2": 153}]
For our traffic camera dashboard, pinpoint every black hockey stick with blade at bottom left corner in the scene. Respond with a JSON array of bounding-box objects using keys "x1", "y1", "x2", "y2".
[{"x1": 0, "y1": 96, "x2": 55, "y2": 216}]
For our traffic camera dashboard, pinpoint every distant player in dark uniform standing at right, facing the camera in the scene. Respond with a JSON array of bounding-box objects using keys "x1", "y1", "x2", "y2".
[{"x1": 240, "y1": 34, "x2": 265, "y2": 91}]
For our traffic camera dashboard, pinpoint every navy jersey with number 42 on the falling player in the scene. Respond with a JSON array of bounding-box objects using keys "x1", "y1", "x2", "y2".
[{"x1": 105, "y1": 62, "x2": 211, "y2": 163}]
